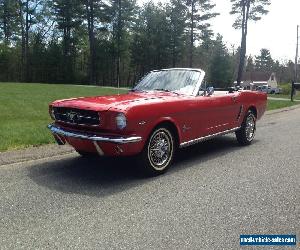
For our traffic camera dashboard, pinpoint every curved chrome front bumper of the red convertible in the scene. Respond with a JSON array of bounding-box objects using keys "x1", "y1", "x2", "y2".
[{"x1": 48, "y1": 124, "x2": 142, "y2": 144}]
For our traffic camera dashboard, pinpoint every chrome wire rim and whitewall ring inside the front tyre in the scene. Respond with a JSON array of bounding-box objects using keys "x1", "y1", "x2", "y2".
[{"x1": 148, "y1": 128, "x2": 174, "y2": 171}]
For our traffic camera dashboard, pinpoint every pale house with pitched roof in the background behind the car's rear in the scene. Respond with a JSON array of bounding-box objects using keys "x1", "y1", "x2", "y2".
[{"x1": 235, "y1": 71, "x2": 278, "y2": 90}]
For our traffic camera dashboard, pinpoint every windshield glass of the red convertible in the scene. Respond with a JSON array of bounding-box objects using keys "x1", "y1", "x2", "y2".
[{"x1": 133, "y1": 70, "x2": 201, "y2": 95}]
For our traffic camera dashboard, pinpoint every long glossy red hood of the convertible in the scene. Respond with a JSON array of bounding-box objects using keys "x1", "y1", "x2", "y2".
[{"x1": 52, "y1": 92, "x2": 183, "y2": 111}]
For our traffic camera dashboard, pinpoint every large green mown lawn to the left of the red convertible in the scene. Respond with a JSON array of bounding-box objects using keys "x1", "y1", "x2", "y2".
[{"x1": 0, "y1": 83, "x2": 124, "y2": 152}]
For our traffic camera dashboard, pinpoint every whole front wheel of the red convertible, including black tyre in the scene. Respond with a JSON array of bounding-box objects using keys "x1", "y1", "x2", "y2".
[{"x1": 139, "y1": 127, "x2": 175, "y2": 176}]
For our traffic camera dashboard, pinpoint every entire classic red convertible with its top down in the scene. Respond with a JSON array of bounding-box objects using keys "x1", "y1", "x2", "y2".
[{"x1": 48, "y1": 69, "x2": 267, "y2": 175}]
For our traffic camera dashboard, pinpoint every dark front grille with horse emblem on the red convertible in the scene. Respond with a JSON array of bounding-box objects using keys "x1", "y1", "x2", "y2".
[{"x1": 53, "y1": 108, "x2": 100, "y2": 126}]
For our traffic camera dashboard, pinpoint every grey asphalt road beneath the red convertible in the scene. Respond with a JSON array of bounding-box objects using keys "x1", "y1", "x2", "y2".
[{"x1": 0, "y1": 109, "x2": 300, "y2": 249}]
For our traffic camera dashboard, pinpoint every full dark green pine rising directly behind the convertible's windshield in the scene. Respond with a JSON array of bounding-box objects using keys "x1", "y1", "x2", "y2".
[{"x1": 131, "y1": 2, "x2": 172, "y2": 77}]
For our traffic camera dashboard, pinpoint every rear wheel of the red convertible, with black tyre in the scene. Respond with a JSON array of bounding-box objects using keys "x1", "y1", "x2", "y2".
[{"x1": 235, "y1": 111, "x2": 256, "y2": 146}]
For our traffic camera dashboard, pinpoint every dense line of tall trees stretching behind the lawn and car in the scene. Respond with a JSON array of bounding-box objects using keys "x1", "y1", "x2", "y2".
[{"x1": 0, "y1": 0, "x2": 294, "y2": 87}]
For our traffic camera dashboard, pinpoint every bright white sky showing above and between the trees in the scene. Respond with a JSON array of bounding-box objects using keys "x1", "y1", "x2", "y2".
[{"x1": 138, "y1": 0, "x2": 300, "y2": 61}]
